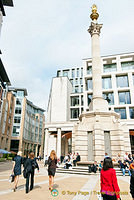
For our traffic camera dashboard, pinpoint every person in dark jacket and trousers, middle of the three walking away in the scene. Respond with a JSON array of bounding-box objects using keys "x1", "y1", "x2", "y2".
[{"x1": 24, "y1": 152, "x2": 39, "y2": 193}]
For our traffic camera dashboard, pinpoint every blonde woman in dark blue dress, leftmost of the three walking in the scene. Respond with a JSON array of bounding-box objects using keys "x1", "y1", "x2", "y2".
[{"x1": 12, "y1": 151, "x2": 22, "y2": 192}]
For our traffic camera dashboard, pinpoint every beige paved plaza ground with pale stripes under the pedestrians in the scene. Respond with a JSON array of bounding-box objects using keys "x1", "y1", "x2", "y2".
[{"x1": 0, "y1": 161, "x2": 132, "y2": 200}]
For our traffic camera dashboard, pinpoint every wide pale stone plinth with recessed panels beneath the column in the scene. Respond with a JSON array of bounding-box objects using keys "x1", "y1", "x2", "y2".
[{"x1": 74, "y1": 111, "x2": 131, "y2": 161}]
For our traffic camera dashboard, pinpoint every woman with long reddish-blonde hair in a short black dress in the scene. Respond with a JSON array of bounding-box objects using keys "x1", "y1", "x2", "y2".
[{"x1": 48, "y1": 150, "x2": 57, "y2": 190}]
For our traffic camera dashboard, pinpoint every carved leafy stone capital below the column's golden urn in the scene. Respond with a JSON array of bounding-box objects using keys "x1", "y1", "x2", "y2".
[{"x1": 88, "y1": 22, "x2": 102, "y2": 36}]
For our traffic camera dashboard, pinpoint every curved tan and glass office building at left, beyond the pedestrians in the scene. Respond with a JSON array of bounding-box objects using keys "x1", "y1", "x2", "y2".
[{"x1": 0, "y1": 87, "x2": 45, "y2": 156}]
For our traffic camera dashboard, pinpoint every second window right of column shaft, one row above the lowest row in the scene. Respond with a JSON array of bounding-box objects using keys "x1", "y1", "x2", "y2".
[{"x1": 119, "y1": 92, "x2": 131, "y2": 104}]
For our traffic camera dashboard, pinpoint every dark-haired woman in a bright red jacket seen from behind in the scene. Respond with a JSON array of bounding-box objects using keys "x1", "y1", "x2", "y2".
[{"x1": 100, "y1": 157, "x2": 120, "y2": 200}]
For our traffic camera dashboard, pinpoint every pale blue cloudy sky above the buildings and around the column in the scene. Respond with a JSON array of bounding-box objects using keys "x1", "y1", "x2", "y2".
[{"x1": 0, "y1": 0, "x2": 134, "y2": 109}]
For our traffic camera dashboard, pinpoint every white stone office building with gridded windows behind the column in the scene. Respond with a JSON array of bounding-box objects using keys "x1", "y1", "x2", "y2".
[{"x1": 45, "y1": 53, "x2": 134, "y2": 161}]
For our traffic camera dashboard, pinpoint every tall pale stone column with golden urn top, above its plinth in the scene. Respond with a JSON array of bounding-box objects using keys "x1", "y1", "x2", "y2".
[{"x1": 88, "y1": 4, "x2": 108, "y2": 111}]
